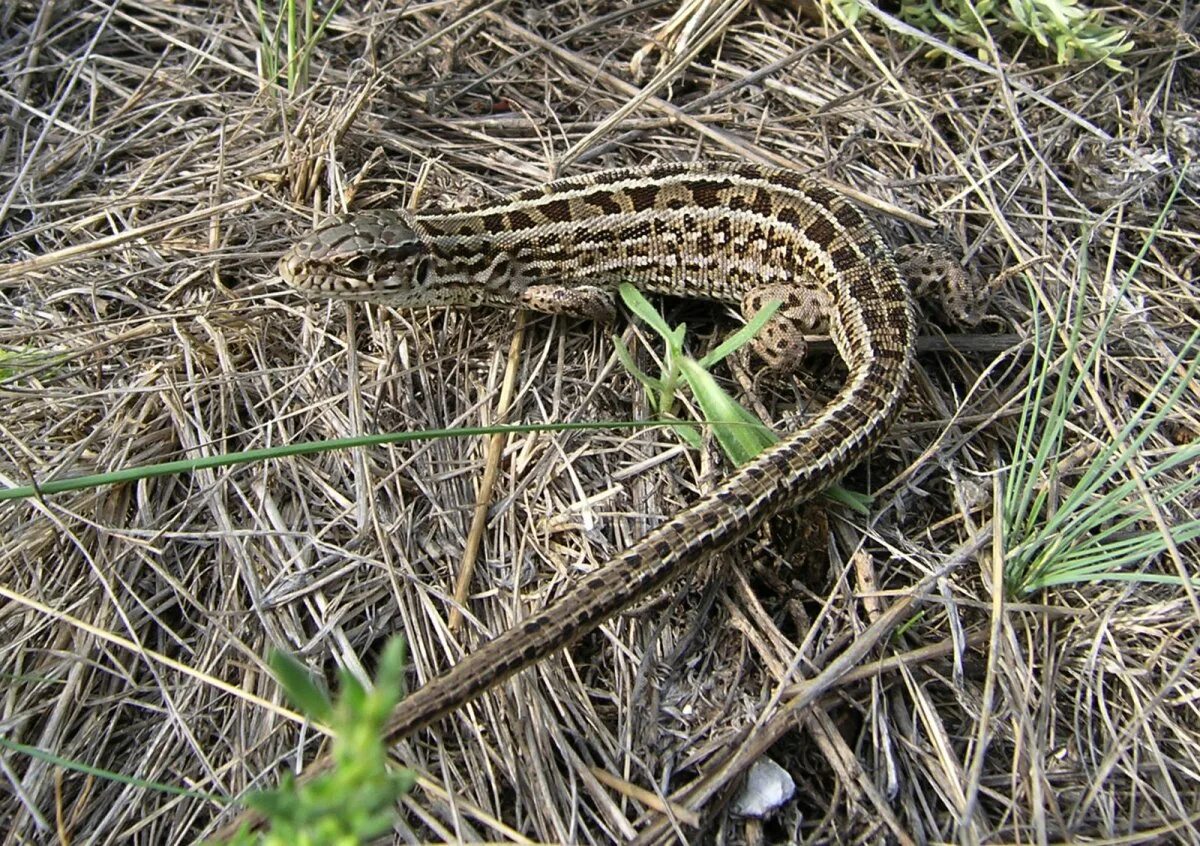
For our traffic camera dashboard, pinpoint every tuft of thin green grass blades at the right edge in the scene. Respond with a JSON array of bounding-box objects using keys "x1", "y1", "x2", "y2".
[{"x1": 1003, "y1": 185, "x2": 1200, "y2": 598}]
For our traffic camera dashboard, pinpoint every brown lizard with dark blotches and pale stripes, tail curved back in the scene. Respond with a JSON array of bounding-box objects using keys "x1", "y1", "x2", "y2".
[{"x1": 280, "y1": 164, "x2": 916, "y2": 740}]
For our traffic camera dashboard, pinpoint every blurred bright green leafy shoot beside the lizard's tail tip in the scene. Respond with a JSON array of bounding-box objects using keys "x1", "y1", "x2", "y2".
[{"x1": 218, "y1": 637, "x2": 416, "y2": 846}]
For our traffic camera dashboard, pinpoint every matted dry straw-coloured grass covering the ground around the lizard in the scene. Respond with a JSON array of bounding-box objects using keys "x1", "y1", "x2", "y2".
[{"x1": 0, "y1": 0, "x2": 1200, "y2": 844}]
